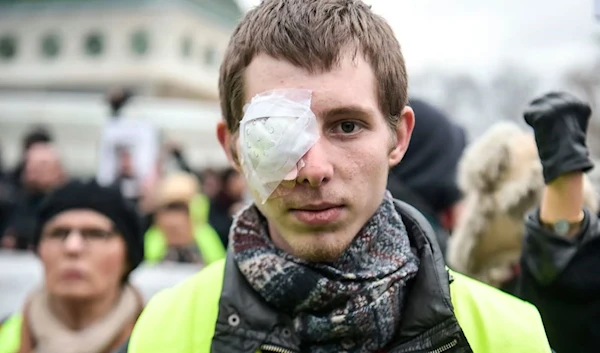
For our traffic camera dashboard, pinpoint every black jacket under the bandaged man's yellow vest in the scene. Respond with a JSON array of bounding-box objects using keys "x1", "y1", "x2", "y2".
[{"x1": 211, "y1": 201, "x2": 472, "y2": 353}]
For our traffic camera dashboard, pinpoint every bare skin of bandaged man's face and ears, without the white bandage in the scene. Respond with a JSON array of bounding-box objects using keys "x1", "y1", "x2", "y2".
[{"x1": 219, "y1": 55, "x2": 414, "y2": 261}]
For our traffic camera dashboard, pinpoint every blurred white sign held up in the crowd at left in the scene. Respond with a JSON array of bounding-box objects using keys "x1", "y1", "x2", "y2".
[{"x1": 97, "y1": 118, "x2": 161, "y2": 190}]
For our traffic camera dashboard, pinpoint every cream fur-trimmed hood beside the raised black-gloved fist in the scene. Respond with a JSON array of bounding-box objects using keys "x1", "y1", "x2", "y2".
[{"x1": 447, "y1": 122, "x2": 598, "y2": 287}]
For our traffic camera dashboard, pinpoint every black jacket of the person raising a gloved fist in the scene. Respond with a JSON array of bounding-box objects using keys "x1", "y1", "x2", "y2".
[{"x1": 518, "y1": 211, "x2": 600, "y2": 353}]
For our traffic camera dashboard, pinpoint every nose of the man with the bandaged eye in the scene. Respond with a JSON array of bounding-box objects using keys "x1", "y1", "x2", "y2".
[{"x1": 296, "y1": 139, "x2": 333, "y2": 188}]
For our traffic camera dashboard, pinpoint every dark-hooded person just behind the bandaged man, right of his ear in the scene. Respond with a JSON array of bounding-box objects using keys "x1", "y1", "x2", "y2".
[{"x1": 388, "y1": 99, "x2": 467, "y2": 254}]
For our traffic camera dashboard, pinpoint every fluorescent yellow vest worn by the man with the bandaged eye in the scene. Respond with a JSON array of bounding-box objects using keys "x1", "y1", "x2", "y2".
[{"x1": 128, "y1": 260, "x2": 551, "y2": 353}]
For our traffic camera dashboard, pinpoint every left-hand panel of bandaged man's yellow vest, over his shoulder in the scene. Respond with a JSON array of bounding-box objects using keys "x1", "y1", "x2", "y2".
[{"x1": 128, "y1": 259, "x2": 225, "y2": 353}]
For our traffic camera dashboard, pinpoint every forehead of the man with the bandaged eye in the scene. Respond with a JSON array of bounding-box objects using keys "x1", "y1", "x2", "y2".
[{"x1": 244, "y1": 54, "x2": 379, "y2": 116}]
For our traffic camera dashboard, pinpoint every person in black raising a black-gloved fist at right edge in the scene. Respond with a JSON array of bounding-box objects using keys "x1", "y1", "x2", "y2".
[{"x1": 518, "y1": 93, "x2": 600, "y2": 353}]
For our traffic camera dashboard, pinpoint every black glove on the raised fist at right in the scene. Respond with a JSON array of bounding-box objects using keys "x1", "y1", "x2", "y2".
[{"x1": 523, "y1": 92, "x2": 594, "y2": 183}]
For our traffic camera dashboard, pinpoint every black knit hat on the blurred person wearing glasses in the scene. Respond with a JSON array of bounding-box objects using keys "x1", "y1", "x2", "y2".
[{"x1": 33, "y1": 180, "x2": 144, "y2": 270}]
